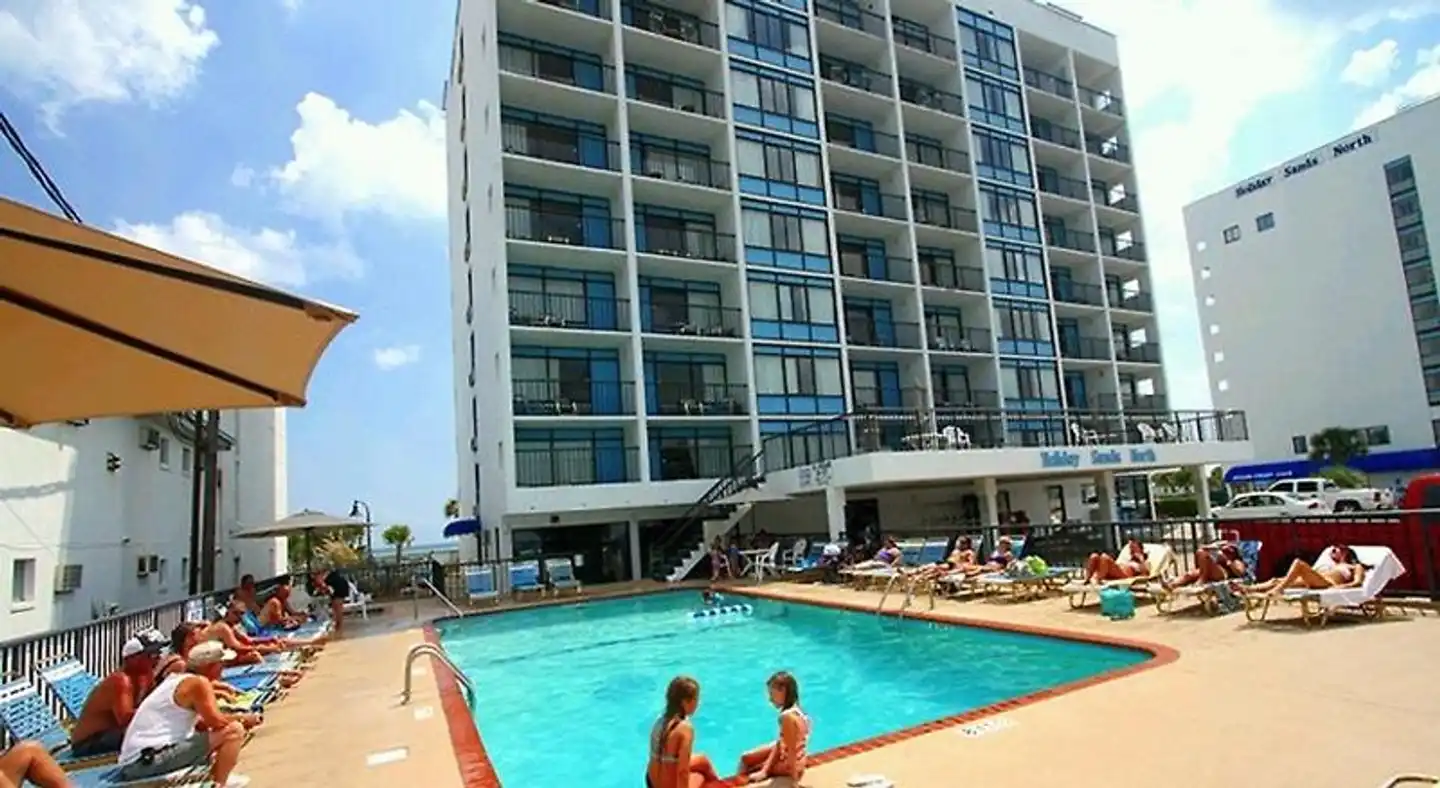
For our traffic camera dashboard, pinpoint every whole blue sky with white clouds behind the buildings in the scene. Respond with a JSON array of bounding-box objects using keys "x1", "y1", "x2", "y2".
[{"x1": 0, "y1": 0, "x2": 1440, "y2": 542}]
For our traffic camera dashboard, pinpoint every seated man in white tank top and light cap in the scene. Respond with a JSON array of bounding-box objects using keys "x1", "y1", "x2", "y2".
[{"x1": 120, "y1": 641, "x2": 261, "y2": 788}]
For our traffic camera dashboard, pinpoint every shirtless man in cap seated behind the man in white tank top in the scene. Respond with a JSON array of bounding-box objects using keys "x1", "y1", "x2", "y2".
[{"x1": 71, "y1": 632, "x2": 160, "y2": 758}]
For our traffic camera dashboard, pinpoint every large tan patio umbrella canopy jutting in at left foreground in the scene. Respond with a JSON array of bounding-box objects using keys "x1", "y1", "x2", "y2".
[{"x1": 0, "y1": 199, "x2": 356, "y2": 426}]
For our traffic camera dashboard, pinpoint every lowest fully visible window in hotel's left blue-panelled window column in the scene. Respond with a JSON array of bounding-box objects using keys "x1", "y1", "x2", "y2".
[{"x1": 755, "y1": 344, "x2": 845, "y2": 415}]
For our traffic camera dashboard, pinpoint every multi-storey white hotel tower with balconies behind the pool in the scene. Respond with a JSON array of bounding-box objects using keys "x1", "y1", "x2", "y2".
[{"x1": 445, "y1": 0, "x2": 1248, "y2": 579}]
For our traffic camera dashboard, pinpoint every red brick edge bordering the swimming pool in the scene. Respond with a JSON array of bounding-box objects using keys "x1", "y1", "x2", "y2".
[{"x1": 425, "y1": 588, "x2": 1179, "y2": 788}]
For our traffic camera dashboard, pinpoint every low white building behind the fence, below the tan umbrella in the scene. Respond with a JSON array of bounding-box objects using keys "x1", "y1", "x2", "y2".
[{"x1": 0, "y1": 409, "x2": 288, "y2": 640}]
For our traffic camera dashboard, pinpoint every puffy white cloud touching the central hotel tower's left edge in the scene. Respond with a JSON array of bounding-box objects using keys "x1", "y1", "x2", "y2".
[{"x1": 268, "y1": 94, "x2": 446, "y2": 220}]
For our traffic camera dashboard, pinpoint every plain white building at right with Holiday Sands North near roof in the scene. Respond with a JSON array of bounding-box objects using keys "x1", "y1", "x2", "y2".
[{"x1": 1185, "y1": 101, "x2": 1440, "y2": 485}]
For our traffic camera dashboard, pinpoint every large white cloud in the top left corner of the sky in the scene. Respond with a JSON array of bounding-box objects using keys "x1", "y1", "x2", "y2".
[{"x1": 0, "y1": 0, "x2": 220, "y2": 128}]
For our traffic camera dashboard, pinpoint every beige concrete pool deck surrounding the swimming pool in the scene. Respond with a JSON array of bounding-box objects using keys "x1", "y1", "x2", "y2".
[{"x1": 230, "y1": 583, "x2": 1440, "y2": 788}]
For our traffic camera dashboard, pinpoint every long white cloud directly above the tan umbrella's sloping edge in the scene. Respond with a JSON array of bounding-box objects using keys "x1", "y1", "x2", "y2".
[{"x1": 114, "y1": 210, "x2": 361, "y2": 288}]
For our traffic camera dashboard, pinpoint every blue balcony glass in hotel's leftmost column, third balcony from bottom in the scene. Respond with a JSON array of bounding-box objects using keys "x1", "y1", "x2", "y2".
[{"x1": 507, "y1": 265, "x2": 629, "y2": 331}]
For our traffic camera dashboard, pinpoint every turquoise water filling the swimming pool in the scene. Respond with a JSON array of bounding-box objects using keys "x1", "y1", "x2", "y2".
[{"x1": 439, "y1": 592, "x2": 1148, "y2": 788}]
